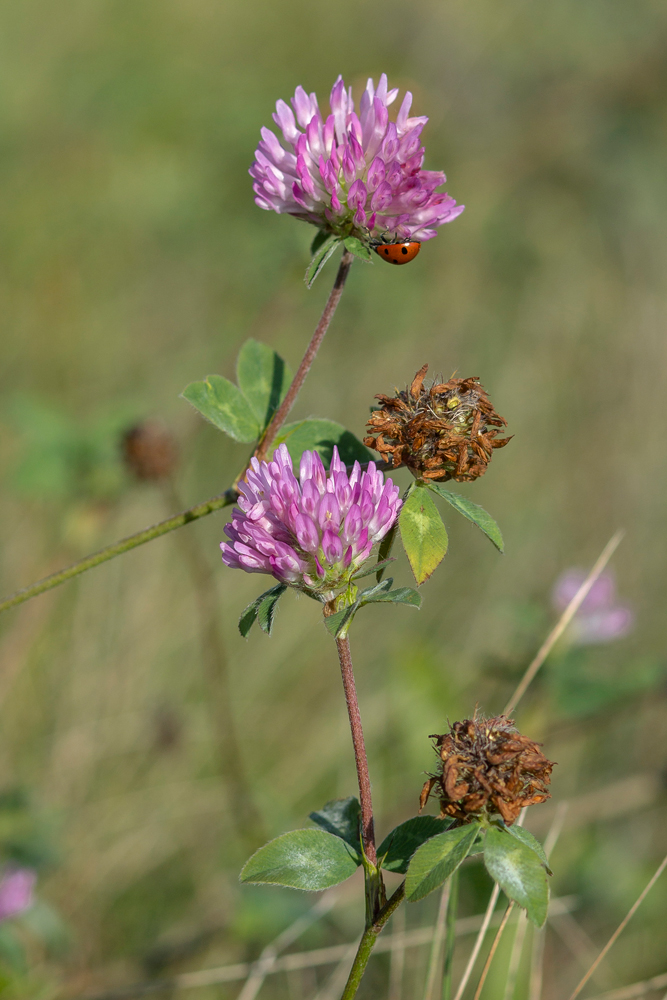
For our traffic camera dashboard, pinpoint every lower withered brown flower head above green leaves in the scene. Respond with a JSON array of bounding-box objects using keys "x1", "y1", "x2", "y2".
[{"x1": 420, "y1": 715, "x2": 553, "y2": 826}]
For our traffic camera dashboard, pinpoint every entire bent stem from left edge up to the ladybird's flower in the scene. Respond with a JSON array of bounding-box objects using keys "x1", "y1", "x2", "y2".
[{"x1": 0, "y1": 250, "x2": 354, "y2": 612}]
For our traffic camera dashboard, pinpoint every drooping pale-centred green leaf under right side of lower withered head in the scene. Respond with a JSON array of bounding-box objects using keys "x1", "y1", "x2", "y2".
[{"x1": 484, "y1": 827, "x2": 549, "y2": 927}]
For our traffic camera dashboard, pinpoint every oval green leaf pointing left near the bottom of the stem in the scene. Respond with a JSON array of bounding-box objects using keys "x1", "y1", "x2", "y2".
[{"x1": 240, "y1": 830, "x2": 358, "y2": 892}]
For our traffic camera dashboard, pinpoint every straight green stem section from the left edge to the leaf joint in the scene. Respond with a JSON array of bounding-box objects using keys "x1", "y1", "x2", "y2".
[{"x1": 0, "y1": 490, "x2": 237, "y2": 612}]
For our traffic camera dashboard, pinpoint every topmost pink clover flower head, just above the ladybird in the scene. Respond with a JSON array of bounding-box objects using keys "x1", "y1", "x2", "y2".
[{"x1": 250, "y1": 73, "x2": 463, "y2": 242}]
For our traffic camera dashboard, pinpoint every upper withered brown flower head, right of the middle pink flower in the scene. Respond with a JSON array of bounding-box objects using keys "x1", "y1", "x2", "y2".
[{"x1": 364, "y1": 365, "x2": 510, "y2": 482}]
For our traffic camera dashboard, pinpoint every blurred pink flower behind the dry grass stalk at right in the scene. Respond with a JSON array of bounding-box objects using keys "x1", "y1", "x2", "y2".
[{"x1": 552, "y1": 569, "x2": 635, "y2": 646}]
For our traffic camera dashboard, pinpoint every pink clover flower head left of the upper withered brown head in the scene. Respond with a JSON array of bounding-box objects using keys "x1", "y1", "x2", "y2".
[{"x1": 220, "y1": 444, "x2": 401, "y2": 600}]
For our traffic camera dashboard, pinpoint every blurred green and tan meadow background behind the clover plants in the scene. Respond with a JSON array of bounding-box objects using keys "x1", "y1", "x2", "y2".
[{"x1": 0, "y1": 0, "x2": 667, "y2": 1000}]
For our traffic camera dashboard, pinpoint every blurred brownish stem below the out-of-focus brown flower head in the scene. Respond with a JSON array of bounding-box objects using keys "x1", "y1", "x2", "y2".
[{"x1": 164, "y1": 481, "x2": 266, "y2": 847}]
